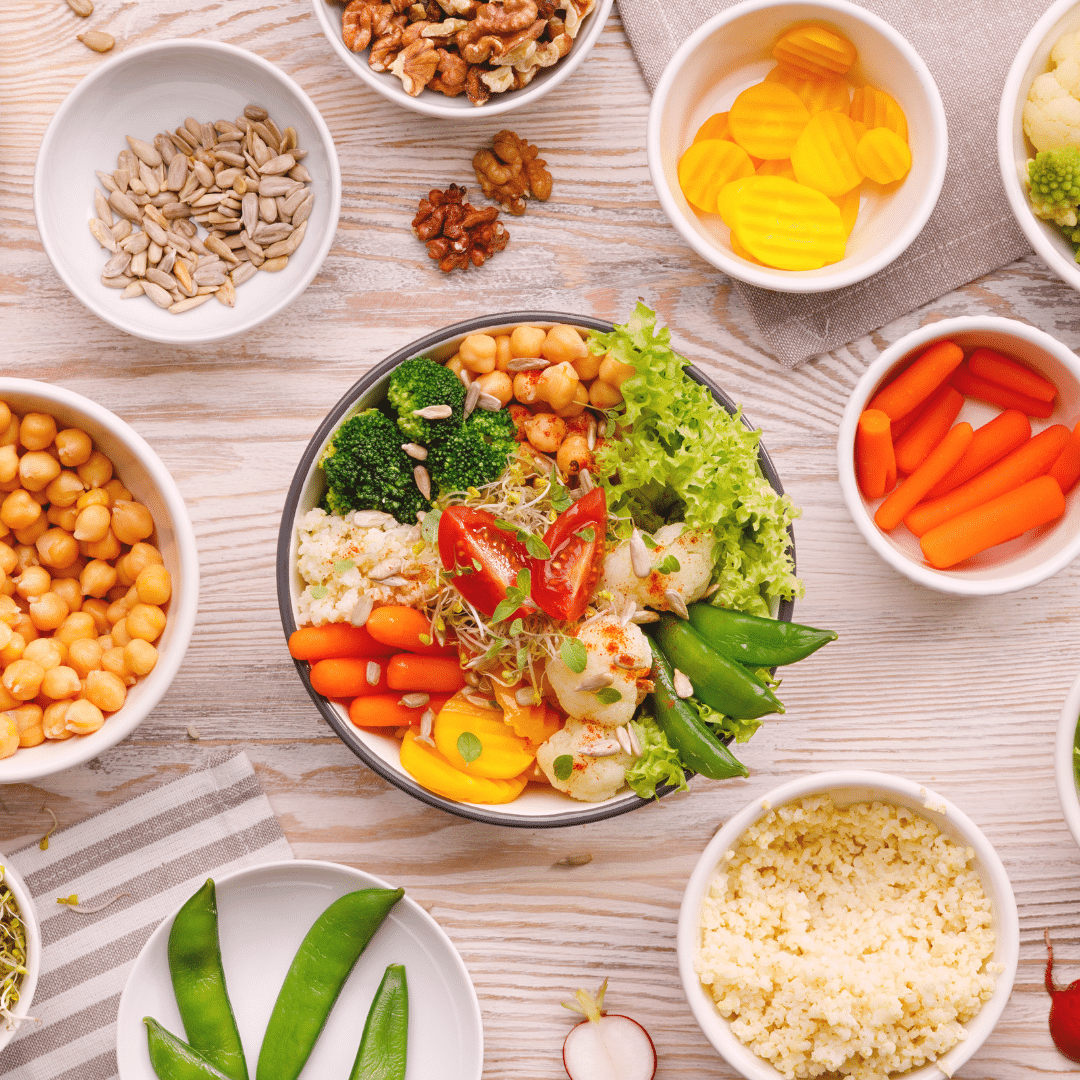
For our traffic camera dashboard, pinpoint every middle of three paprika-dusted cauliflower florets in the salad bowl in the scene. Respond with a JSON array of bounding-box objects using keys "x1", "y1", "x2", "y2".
[{"x1": 546, "y1": 615, "x2": 652, "y2": 728}]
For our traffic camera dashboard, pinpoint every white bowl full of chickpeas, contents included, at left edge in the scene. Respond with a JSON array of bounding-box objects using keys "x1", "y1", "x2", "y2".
[{"x1": 0, "y1": 378, "x2": 199, "y2": 783}]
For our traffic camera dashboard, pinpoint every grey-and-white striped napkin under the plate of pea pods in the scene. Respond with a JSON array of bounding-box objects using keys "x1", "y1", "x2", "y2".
[{"x1": 0, "y1": 751, "x2": 293, "y2": 1080}]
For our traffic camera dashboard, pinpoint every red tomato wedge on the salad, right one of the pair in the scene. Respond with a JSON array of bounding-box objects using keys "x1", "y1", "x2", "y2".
[{"x1": 532, "y1": 487, "x2": 607, "y2": 622}]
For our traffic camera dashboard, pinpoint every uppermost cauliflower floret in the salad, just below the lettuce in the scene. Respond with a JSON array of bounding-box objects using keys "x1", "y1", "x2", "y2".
[{"x1": 602, "y1": 524, "x2": 717, "y2": 611}]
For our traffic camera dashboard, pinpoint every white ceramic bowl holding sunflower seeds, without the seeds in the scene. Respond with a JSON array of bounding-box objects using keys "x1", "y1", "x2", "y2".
[{"x1": 33, "y1": 40, "x2": 341, "y2": 345}]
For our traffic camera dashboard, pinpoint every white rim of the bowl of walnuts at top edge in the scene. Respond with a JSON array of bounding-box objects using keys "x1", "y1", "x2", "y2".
[{"x1": 311, "y1": 0, "x2": 615, "y2": 120}]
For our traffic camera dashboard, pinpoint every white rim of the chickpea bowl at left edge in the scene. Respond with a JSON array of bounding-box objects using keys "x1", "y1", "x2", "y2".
[{"x1": 0, "y1": 377, "x2": 199, "y2": 784}]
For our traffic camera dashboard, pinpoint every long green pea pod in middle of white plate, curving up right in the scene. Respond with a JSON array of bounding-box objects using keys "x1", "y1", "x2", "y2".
[{"x1": 255, "y1": 889, "x2": 405, "y2": 1080}]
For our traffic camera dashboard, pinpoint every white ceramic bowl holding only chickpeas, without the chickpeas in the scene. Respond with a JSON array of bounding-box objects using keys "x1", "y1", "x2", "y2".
[{"x1": 0, "y1": 378, "x2": 199, "y2": 784}]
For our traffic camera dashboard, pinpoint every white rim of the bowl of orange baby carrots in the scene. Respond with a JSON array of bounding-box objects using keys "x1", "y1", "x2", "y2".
[{"x1": 836, "y1": 315, "x2": 1080, "y2": 596}]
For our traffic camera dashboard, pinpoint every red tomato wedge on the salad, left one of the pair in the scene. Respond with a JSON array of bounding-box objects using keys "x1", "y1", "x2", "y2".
[{"x1": 438, "y1": 507, "x2": 529, "y2": 618}]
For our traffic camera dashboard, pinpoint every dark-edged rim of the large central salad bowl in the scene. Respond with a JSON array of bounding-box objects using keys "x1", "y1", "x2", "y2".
[{"x1": 276, "y1": 311, "x2": 796, "y2": 828}]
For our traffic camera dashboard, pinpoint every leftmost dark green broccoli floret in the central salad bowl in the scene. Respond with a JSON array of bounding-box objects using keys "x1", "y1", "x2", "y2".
[{"x1": 319, "y1": 408, "x2": 431, "y2": 525}]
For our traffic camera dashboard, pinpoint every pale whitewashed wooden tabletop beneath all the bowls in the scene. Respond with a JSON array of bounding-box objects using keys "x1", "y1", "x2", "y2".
[{"x1": 0, "y1": 0, "x2": 1080, "y2": 1080}]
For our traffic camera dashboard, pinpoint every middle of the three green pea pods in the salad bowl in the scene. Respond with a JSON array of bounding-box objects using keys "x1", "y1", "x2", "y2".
[{"x1": 657, "y1": 615, "x2": 784, "y2": 720}]
